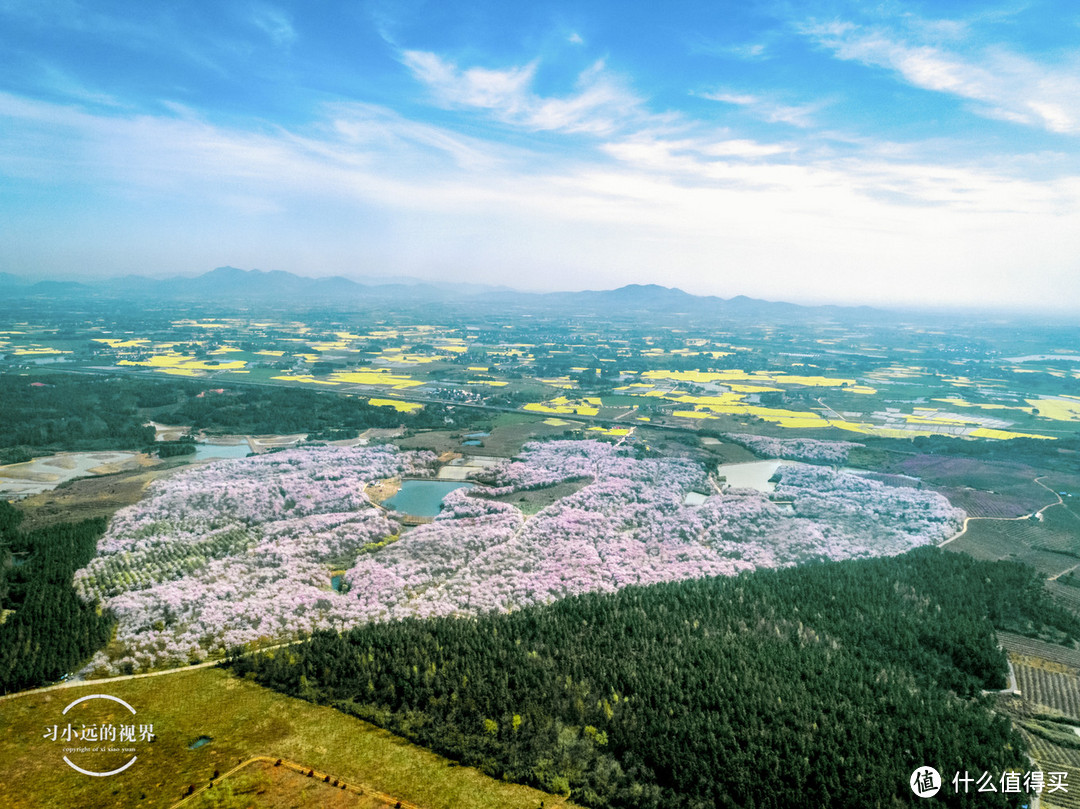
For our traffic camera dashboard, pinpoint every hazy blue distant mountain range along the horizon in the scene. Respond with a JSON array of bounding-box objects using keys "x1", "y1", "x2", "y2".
[{"x1": 0, "y1": 267, "x2": 881, "y2": 320}]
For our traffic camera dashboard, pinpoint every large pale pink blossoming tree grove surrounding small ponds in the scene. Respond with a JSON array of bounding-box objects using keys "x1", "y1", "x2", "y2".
[{"x1": 76, "y1": 441, "x2": 963, "y2": 672}]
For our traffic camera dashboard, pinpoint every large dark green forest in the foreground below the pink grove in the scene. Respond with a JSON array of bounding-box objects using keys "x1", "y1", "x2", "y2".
[{"x1": 232, "y1": 549, "x2": 1080, "y2": 809}]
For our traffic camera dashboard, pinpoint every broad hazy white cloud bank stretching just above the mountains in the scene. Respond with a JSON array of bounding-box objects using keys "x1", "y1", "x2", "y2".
[{"x1": 0, "y1": 94, "x2": 1080, "y2": 306}]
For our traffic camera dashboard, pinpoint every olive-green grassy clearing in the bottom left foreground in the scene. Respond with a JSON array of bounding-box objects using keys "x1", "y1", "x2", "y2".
[{"x1": 0, "y1": 668, "x2": 571, "y2": 809}]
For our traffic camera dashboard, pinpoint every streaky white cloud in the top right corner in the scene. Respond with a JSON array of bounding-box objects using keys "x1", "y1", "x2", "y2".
[{"x1": 800, "y1": 19, "x2": 1080, "y2": 135}]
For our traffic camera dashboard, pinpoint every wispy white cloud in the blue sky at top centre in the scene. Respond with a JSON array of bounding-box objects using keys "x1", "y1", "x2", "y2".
[{"x1": 402, "y1": 51, "x2": 645, "y2": 135}]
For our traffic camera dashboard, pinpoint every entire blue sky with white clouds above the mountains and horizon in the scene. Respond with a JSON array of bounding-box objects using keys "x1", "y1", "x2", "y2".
[{"x1": 0, "y1": 0, "x2": 1080, "y2": 310}]
